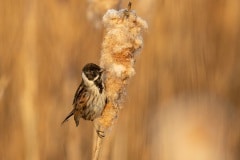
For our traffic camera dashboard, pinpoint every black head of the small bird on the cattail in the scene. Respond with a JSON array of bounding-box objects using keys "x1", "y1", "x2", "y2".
[{"x1": 82, "y1": 63, "x2": 103, "y2": 81}]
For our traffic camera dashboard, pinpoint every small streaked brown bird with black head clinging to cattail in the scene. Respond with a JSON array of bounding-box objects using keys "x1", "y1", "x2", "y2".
[{"x1": 62, "y1": 63, "x2": 107, "y2": 126}]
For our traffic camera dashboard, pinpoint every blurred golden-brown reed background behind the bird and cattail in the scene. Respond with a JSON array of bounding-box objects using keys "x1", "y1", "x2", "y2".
[{"x1": 0, "y1": 0, "x2": 240, "y2": 160}]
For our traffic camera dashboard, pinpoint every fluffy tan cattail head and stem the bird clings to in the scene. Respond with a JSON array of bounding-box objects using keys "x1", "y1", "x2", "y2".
[{"x1": 93, "y1": 3, "x2": 147, "y2": 160}]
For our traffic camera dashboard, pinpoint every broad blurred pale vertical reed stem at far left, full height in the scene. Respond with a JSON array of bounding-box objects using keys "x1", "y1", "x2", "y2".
[{"x1": 18, "y1": 0, "x2": 39, "y2": 160}]
